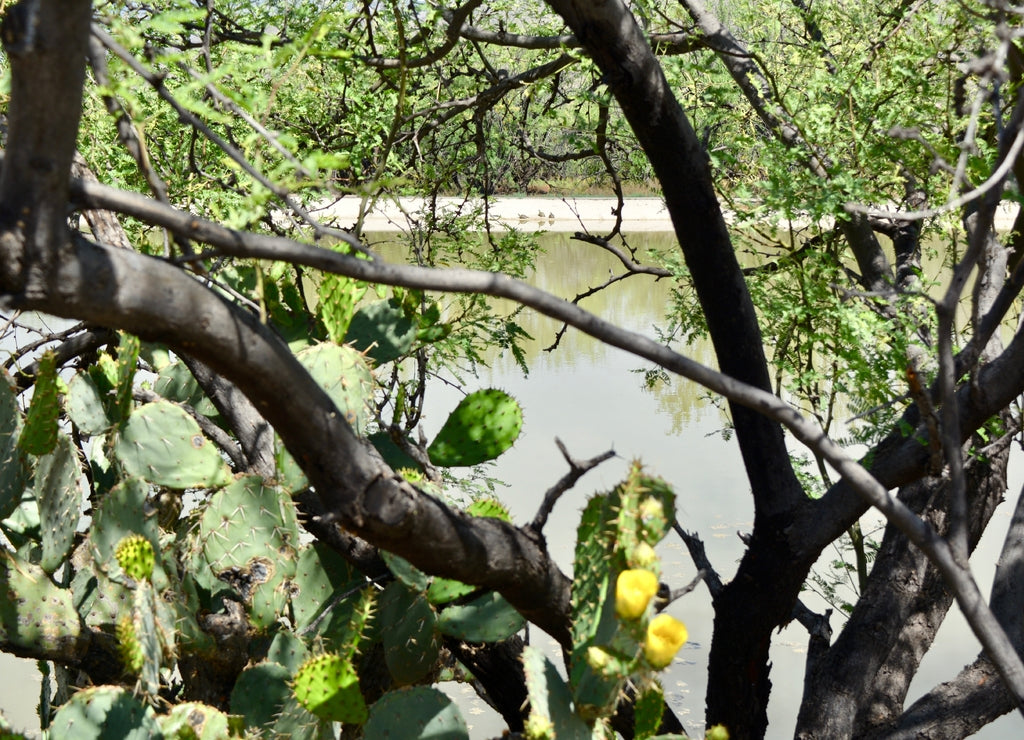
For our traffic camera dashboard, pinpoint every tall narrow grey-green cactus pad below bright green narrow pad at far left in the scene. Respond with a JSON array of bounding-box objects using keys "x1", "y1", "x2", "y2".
[{"x1": 34, "y1": 434, "x2": 82, "y2": 573}]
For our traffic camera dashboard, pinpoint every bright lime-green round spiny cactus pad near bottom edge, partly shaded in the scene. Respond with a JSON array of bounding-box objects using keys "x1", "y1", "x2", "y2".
[{"x1": 292, "y1": 653, "x2": 367, "y2": 725}]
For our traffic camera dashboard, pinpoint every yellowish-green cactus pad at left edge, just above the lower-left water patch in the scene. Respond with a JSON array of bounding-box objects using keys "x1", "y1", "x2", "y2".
[{"x1": 0, "y1": 550, "x2": 88, "y2": 660}]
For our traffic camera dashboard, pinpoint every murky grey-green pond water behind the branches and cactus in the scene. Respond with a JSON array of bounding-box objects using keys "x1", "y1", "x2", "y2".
[{"x1": 0, "y1": 227, "x2": 1024, "y2": 738}]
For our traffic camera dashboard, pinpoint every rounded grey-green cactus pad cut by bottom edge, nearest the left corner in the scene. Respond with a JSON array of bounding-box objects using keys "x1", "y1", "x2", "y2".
[{"x1": 50, "y1": 686, "x2": 163, "y2": 740}]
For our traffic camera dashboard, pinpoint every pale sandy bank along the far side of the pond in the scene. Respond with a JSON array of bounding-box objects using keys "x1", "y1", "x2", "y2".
[{"x1": 310, "y1": 195, "x2": 1019, "y2": 233}]
